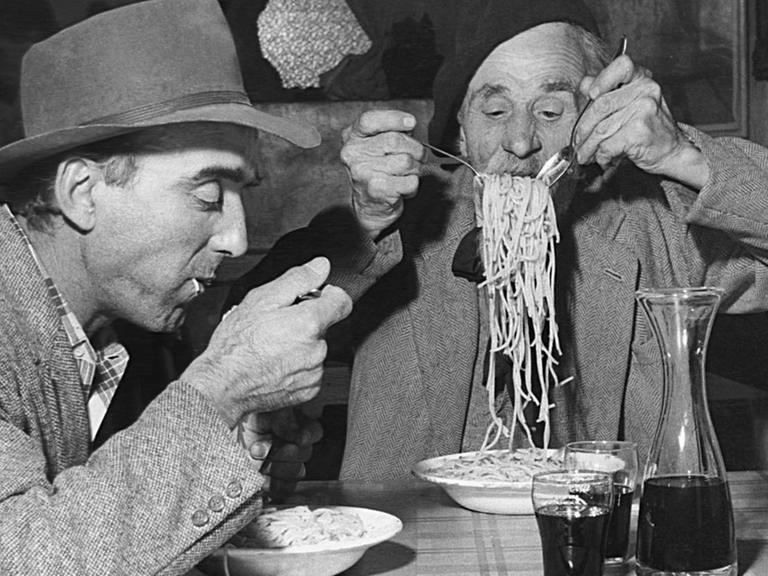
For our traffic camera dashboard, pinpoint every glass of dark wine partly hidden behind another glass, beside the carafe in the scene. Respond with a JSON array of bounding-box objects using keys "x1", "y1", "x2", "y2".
[{"x1": 564, "y1": 440, "x2": 640, "y2": 565}]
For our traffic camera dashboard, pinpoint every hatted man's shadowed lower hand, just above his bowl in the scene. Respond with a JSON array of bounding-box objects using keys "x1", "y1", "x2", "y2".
[{"x1": 237, "y1": 408, "x2": 323, "y2": 502}]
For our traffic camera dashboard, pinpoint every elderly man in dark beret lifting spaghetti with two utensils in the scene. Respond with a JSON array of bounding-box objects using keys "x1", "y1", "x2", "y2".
[{"x1": 228, "y1": 0, "x2": 768, "y2": 479}]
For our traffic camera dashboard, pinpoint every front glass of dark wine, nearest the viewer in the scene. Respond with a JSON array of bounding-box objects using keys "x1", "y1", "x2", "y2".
[{"x1": 531, "y1": 470, "x2": 614, "y2": 576}]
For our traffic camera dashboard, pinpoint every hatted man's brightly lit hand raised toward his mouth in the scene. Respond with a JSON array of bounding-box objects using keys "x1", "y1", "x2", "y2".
[{"x1": 181, "y1": 258, "x2": 352, "y2": 428}]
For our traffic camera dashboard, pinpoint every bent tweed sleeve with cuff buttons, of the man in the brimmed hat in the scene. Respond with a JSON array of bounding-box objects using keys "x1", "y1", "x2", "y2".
[{"x1": 0, "y1": 382, "x2": 263, "y2": 576}]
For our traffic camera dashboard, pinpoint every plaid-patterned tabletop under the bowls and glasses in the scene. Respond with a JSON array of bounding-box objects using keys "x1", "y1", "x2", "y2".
[{"x1": 282, "y1": 471, "x2": 768, "y2": 576}]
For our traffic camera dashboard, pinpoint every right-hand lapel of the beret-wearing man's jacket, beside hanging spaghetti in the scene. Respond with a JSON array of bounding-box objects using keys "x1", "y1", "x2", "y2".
[{"x1": 556, "y1": 203, "x2": 639, "y2": 439}]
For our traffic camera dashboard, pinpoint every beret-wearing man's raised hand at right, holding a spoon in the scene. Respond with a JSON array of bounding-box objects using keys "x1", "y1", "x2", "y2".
[{"x1": 576, "y1": 55, "x2": 709, "y2": 190}]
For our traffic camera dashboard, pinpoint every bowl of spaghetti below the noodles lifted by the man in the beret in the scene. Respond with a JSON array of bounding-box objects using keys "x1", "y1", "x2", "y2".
[{"x1": 413, "y1": 448, "x2": 563, "y2": 514}]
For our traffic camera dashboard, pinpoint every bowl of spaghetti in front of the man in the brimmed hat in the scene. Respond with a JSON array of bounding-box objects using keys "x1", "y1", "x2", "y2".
[{"x1": 201, "y1": 505, "x2": 403, "y2": 576}]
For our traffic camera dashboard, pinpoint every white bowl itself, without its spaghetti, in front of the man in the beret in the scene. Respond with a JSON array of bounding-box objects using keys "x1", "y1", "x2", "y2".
[{"x1": 413, "y1": 450, "x2": 562, "y2": 515}]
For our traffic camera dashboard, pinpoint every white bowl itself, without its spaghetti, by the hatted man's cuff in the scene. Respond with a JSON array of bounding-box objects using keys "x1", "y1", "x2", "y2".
[{"x1": 202, "y1": 506, "x2": 403, "y2": 576}]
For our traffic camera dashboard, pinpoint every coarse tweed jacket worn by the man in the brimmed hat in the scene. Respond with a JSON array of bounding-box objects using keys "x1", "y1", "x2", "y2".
[{"x1": 0, "y1": 214, "x2": 263, "y2": 576}]
